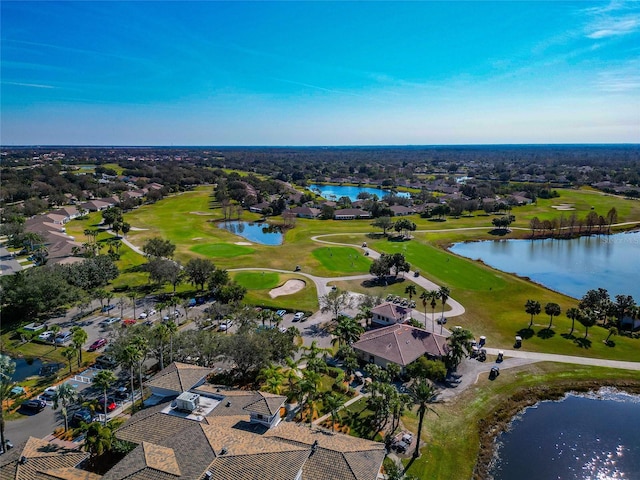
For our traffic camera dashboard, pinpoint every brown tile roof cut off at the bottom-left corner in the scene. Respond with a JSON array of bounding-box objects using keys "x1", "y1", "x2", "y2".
[{"x1": 0, "y1": 437, "x2": 101, "y2": 480}]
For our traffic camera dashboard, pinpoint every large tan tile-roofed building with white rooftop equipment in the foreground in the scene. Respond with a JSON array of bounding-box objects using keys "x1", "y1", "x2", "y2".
[{"x1": 103, "y1": 378, "x2": 385, "y2": 480}]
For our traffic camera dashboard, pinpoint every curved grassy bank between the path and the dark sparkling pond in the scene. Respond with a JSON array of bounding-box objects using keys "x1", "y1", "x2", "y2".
[{"x1": 403, "y1": 363, "x2": 640, "y2": 480}]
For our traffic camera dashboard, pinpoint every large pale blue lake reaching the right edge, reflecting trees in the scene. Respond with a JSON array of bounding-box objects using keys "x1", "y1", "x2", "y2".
[{"x1": 450, "y1": 232, "x2": 640, "y2": 300}]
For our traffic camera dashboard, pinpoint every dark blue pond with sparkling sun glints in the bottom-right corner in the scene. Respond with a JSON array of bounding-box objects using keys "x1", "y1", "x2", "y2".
[{"x1": 491, "y1": 389, "x2": 640, "y2": 480}]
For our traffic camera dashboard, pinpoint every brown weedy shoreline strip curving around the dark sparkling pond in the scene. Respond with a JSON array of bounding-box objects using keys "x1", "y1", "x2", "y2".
[{"x1": 471, "y1": 379, "x2": 640, "y2": 480}]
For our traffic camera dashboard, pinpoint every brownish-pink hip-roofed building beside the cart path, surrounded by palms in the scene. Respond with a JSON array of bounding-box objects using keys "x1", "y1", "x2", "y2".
[{"x1": 353, "y1": 324, "x2": 447, "y2": 369}]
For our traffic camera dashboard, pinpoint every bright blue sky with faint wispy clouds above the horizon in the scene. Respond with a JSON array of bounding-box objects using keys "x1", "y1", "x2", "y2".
[{"x1": 0, "y1": 0, "x2": 640, "y2": 145}]
